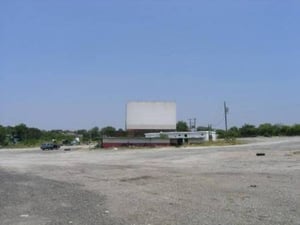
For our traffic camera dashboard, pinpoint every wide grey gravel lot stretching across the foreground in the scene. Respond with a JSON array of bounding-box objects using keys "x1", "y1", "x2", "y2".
[{"x1": 0, "y1": 137, "x2": 300, "y2": 225}]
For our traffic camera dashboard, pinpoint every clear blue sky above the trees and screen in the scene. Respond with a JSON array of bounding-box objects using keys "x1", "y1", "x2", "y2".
[{"x1": 0, "y1": 0, "x2": 300, "y2": 129}]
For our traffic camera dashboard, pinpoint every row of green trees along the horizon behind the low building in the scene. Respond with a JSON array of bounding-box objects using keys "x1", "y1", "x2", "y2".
[{"x1": 0, "y1": 121, "x2": 300, "y2": 147}]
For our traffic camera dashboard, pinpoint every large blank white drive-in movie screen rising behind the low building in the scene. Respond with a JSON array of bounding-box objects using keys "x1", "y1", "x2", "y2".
[{"x1": 126, "y1": 102, "x2": 176, "y2": 130}]
